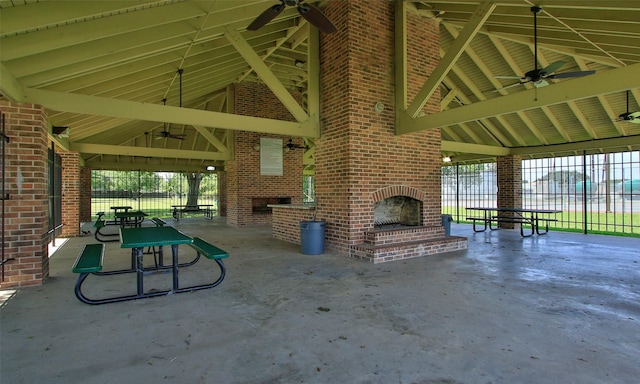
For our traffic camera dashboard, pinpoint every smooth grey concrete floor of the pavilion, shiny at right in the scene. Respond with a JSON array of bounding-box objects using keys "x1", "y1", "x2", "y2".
[{"x1": 0, "y1": 218, "x2": 640, "y2": 384}]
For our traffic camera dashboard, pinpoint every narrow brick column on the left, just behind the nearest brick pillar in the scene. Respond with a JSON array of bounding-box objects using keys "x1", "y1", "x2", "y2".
[{"x1": 56, "y1": 152, "x2": 80, "y2": 237}]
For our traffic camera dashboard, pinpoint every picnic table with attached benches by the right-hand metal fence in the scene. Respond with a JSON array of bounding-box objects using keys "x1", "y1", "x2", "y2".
[{"x1": 466, "y1": 207, "x2": 562, "y2": 237}]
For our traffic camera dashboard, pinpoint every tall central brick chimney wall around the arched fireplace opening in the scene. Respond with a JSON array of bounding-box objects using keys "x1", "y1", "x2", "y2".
[{"x1": 316, "y1": 0, "x2": 441, "y2": 254}]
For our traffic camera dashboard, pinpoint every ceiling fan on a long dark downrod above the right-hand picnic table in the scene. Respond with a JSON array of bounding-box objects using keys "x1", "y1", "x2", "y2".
[{"x1": 495, "y1": 6, "x2": 596, "y2": 91}]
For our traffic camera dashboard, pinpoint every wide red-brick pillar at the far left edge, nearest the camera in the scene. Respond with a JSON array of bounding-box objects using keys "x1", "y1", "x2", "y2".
[{"x1": 0, "y1": 100, "x2": 49, "y2": 288}]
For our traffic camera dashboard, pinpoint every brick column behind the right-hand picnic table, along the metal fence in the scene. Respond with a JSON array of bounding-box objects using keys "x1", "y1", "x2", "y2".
[{"x1": 497, "y1": 156, "x2": 522, "y2": 228}]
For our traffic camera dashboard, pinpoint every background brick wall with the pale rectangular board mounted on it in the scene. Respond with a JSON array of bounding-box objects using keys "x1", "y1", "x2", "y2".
[{"x1": 225, "y1": 83, "x2": 303, "y2": 227}]
